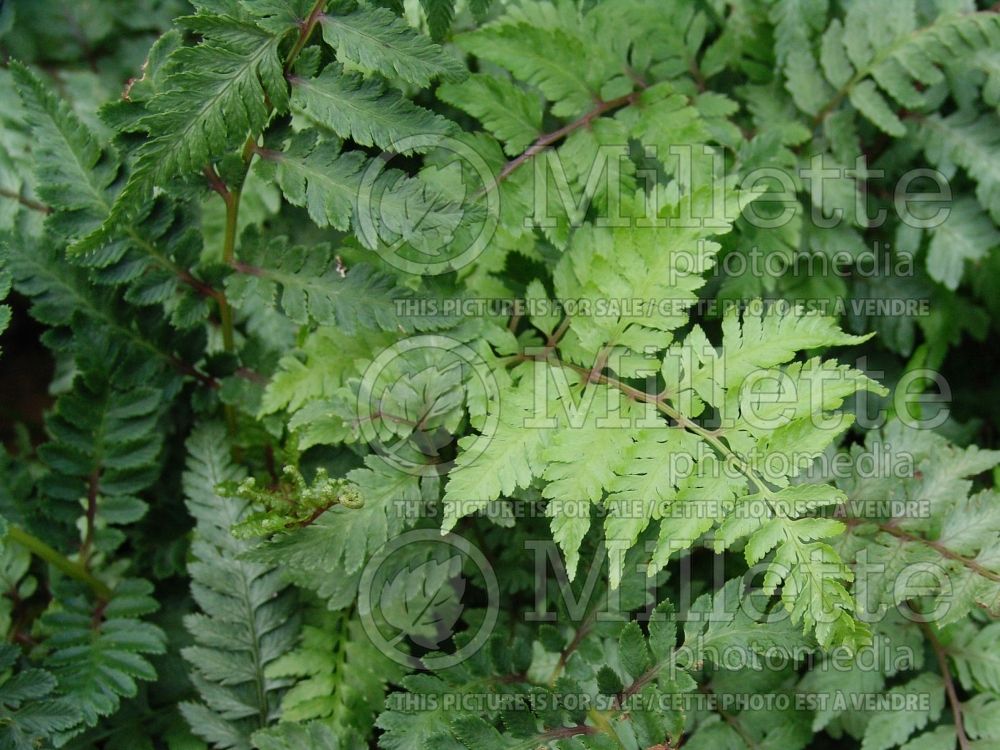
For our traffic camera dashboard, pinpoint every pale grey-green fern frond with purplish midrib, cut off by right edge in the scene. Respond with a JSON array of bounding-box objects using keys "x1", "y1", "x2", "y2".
[{"x1": 839, "y1": 421, "x2": 1000, "y2": 627}]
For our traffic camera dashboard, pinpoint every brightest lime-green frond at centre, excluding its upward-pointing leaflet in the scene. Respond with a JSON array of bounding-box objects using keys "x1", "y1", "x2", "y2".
[{"x1": 444, "y1": 298, "x2": 884, "y2": 644}]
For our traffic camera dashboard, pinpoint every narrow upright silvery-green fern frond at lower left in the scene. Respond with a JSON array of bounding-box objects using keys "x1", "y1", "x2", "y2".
[{"x1": 181, "y1": 425, "x2": 299, "y2": 750}]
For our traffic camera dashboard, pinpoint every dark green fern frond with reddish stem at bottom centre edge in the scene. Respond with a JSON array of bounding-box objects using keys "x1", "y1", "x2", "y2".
[{"x1": 378, "y1": 581, "x2": 805, "y2": 750}]
